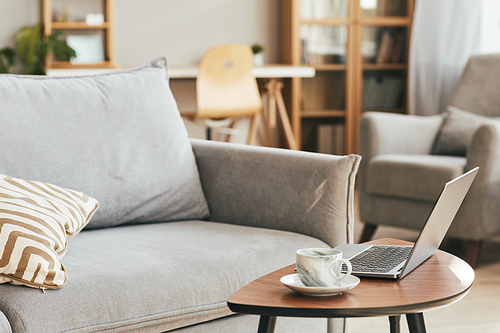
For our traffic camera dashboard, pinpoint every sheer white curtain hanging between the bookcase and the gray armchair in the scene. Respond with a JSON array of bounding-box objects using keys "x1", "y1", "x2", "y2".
[{"x1": 408, "y1": 0, "x2": 481, "y2": 115}]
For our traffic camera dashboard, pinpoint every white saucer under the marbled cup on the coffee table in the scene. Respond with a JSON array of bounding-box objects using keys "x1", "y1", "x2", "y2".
[{"x1": 280, "y1": 274, "x2": 359, "y2": 296}]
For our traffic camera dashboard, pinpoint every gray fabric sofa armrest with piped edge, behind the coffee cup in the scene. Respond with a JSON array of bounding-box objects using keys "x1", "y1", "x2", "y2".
[{"x1": 191, "y1": 139, "x2": 361, "y2": 246}]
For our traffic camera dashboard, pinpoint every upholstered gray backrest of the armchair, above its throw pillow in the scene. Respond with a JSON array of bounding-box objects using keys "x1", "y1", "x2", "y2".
[{"x1": 450, "y1": 54, "x2": 500, "y2": 117}]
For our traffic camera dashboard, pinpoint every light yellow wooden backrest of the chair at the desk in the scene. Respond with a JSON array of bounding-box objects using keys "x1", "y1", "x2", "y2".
[{"x1": 195, "y1": 44, "x2": 262, "y2": 118}]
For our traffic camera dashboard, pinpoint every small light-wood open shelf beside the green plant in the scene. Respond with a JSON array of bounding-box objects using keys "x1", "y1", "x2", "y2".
[{"x1": 42, "y1": 0, "x2": 116, "y2": 69}]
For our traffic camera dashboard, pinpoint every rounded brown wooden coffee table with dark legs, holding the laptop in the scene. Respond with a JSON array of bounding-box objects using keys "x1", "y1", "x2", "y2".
[{"x1": 227, "y1": 238, "x2": 474, "y2": 333}]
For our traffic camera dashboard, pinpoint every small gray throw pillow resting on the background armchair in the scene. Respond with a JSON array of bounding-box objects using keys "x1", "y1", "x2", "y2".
[{"x1": 432, "y1": 106, "x2": 498, "y2": 156}]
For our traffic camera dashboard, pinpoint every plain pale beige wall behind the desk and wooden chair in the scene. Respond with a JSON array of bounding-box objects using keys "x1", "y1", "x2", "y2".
[{"x1": 0, "y1": 0, "x2": 279, "y2": 142}]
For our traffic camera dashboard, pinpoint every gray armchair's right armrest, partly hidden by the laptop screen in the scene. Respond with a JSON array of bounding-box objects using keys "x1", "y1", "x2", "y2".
[{"x1": 456, "y1": 121, "x2": 500, "y2": 239}]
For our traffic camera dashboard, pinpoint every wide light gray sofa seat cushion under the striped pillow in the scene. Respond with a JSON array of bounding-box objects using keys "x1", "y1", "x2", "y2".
[{"x1": 0, "y1": 221, "x2": 327, "y2": 333}]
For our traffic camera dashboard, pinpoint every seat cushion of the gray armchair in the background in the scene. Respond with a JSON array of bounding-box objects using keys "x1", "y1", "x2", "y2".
[{"x1": 366, "y1": 154, "x2": 466, "y2": 202}]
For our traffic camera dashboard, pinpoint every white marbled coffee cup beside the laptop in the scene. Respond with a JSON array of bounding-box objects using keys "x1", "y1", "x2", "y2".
[{"x1": 297, "y1": 248, "x2": 352, "y2": 287}]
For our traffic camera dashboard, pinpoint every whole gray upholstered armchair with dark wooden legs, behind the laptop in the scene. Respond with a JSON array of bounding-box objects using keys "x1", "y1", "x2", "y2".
[{"x1": 359, "y1": 54, "x2": 500, "y2": 267}]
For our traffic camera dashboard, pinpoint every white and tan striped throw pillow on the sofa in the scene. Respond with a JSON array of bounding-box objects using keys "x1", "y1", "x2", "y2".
[{"x1": 0, "y1": 175, "x2": 99, "y2": 291}]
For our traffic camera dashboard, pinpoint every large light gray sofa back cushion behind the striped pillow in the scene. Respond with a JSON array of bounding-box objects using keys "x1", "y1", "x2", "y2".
[{"x1": 0, "y1": 58, "x2": 209, "y2": 228}]
